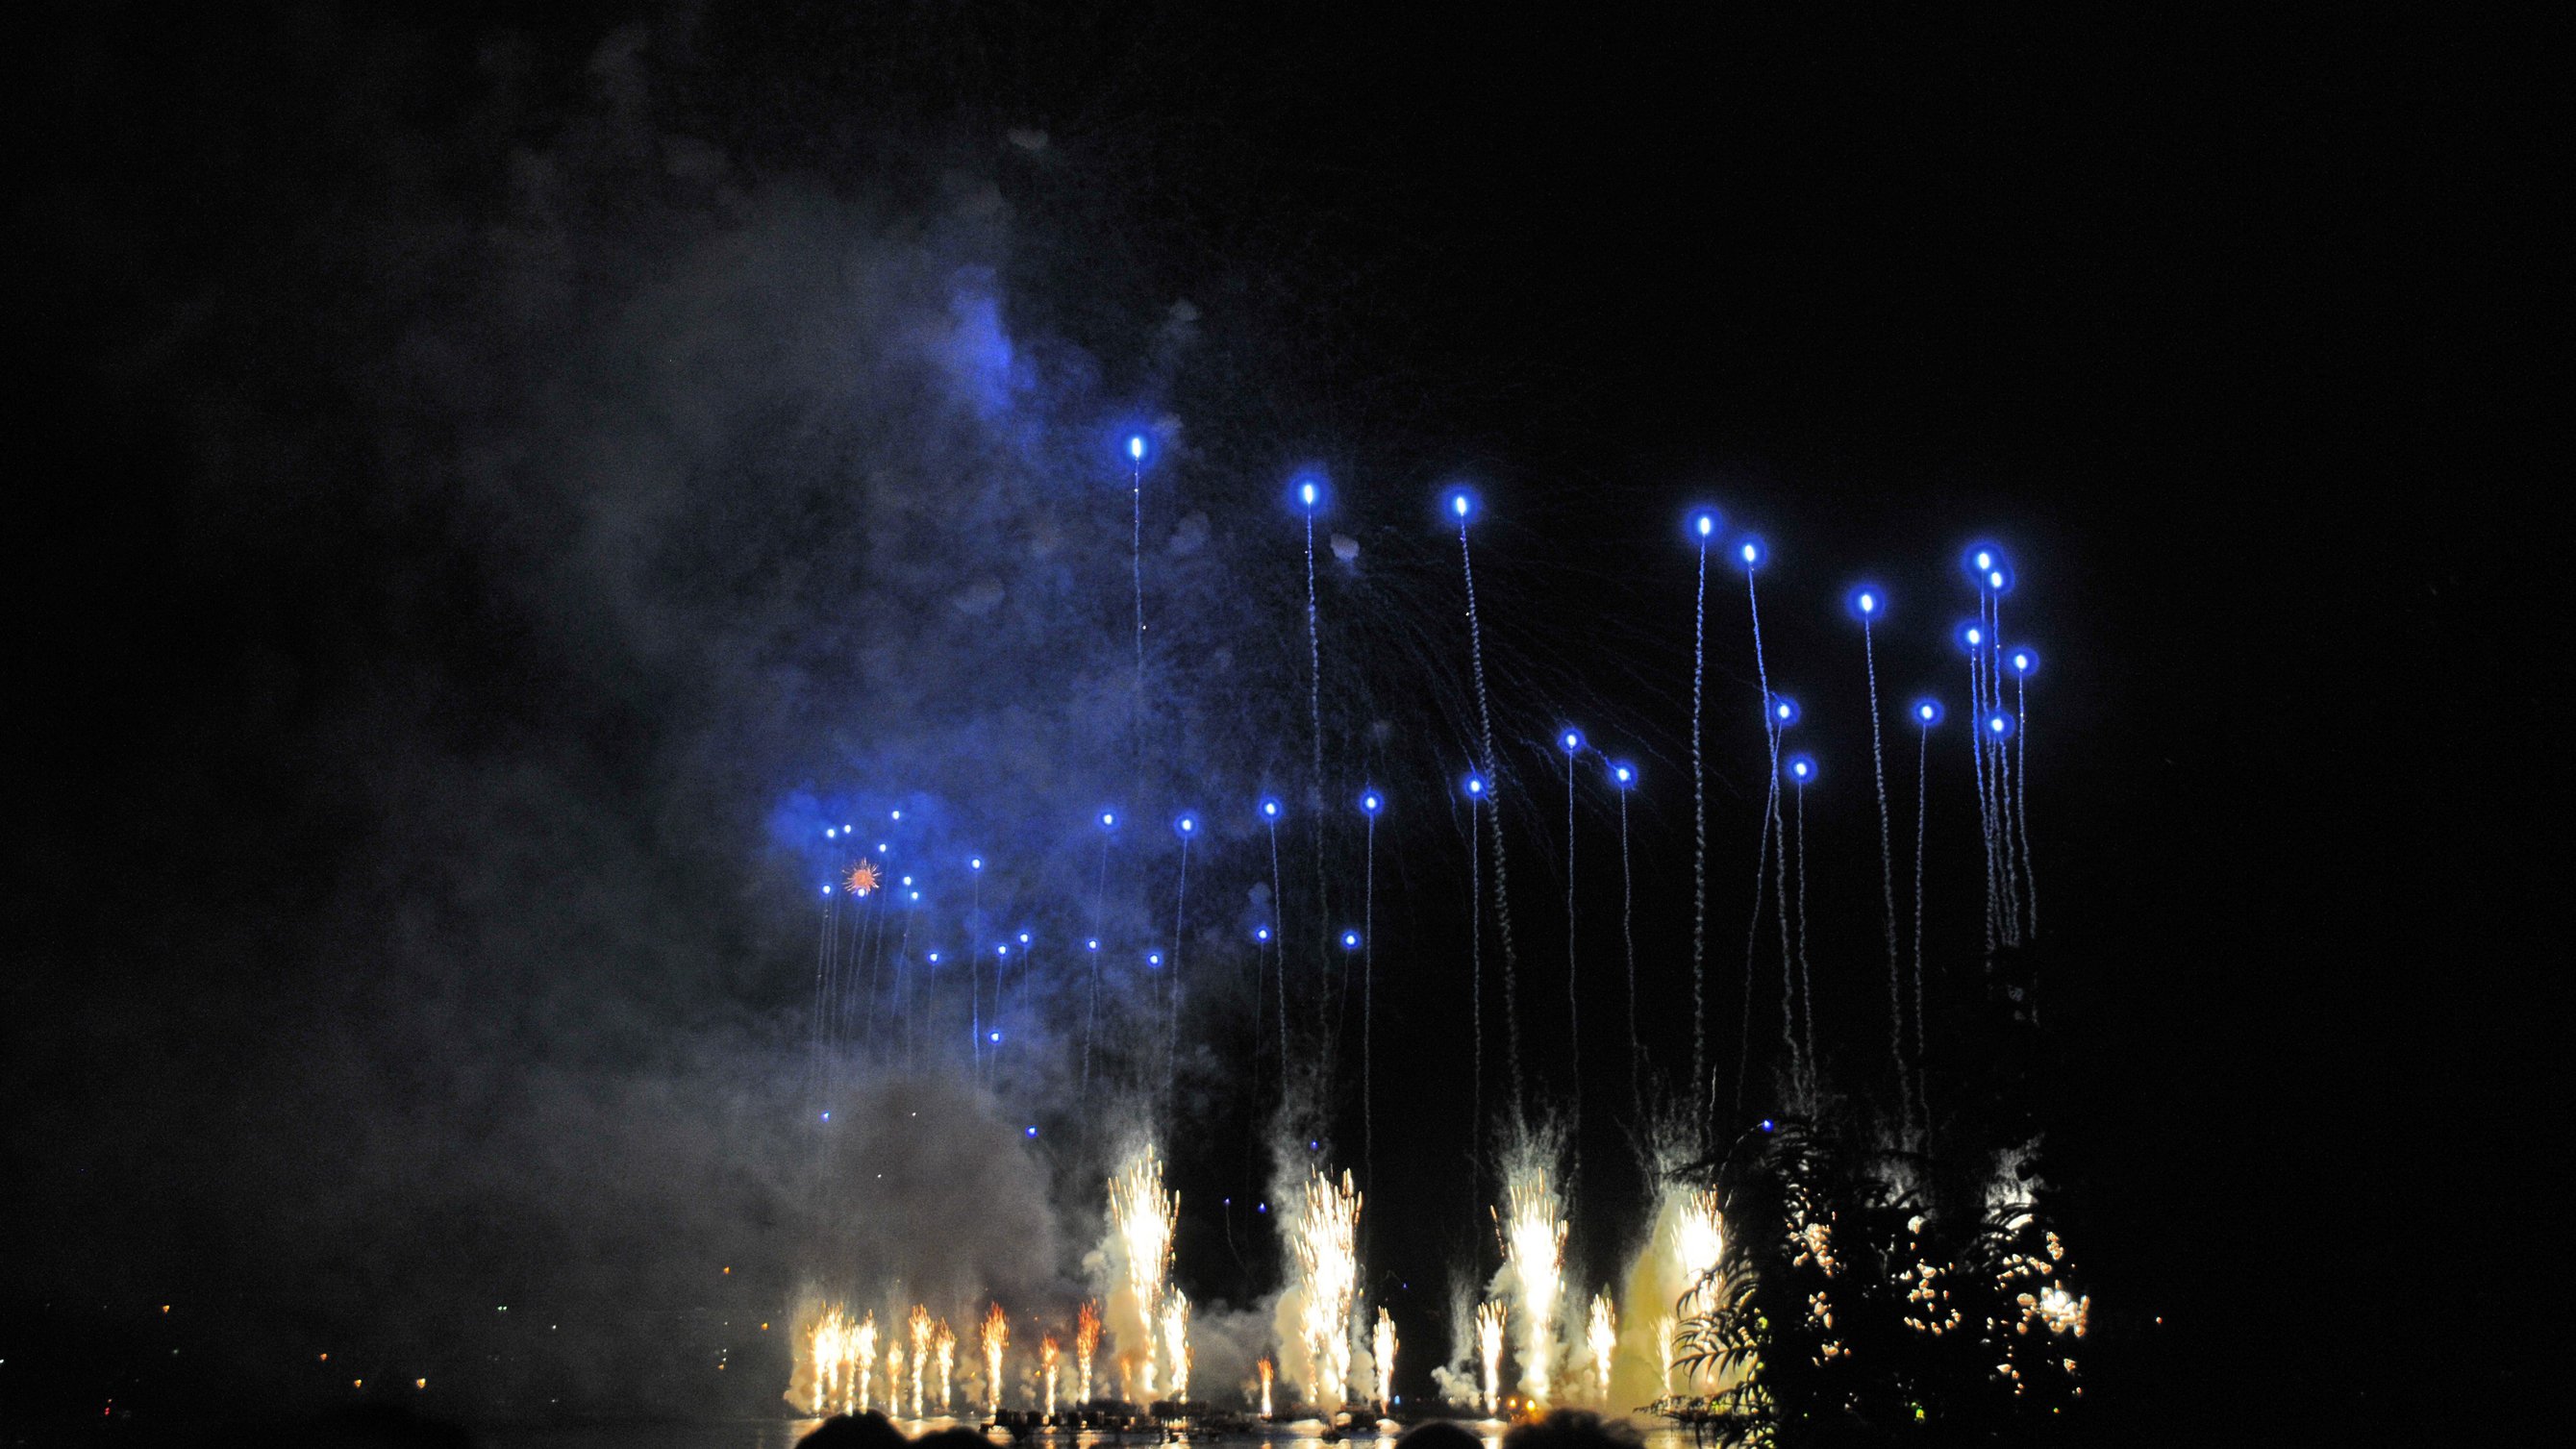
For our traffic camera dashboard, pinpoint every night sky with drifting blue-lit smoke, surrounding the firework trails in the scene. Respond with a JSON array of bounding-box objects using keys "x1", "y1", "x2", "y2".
[{"x1": 0, "y1": 3, "x2": 2565, "y2": 1434}]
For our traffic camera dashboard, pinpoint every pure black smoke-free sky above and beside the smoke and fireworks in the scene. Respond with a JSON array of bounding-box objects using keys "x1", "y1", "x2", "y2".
[{"x1": 5, "y1": 5, "x2": 2565, "y2": 1431}]
